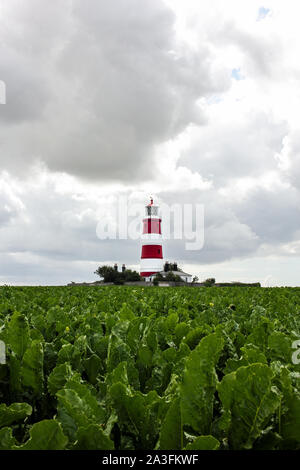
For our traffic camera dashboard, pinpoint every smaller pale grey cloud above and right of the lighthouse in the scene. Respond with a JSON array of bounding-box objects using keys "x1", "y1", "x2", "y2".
[{"x1": 179, "y1": 112, "x2": 288, "y2": 187}]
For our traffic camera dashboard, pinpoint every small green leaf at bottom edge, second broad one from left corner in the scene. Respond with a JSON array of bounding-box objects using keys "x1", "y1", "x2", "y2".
[{"x1": 74, "y1": 424, "x2": 114, "y2": 450}]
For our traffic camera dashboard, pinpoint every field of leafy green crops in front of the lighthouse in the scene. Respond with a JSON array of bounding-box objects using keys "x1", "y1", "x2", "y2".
[{"x1": 0, "y1": 286, "x2": 300, "y2": 450}]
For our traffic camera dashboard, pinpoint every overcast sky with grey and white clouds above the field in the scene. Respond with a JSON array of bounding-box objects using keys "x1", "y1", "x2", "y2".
[{"x1": 0, "y1": 0, "x2": 300, "y2": 286}]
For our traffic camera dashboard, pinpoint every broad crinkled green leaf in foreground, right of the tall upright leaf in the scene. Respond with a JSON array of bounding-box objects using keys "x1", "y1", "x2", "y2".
[{"x1": 218, "y1": 364, "x2": 281, "y2": 449}]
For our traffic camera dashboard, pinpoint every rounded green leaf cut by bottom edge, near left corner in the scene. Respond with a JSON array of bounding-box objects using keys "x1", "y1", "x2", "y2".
[{"x1": 13, "y1": 419, "x2": 68, "y2": 450}]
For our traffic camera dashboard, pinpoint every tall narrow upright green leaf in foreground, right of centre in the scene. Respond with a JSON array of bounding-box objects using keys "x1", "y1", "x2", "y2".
[{"x1": 180, "y1": 333, "x2": 223, "y2": 435}]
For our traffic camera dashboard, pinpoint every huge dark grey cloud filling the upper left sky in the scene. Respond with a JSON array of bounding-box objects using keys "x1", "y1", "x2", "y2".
[{"x1": 0, "y1": 0, "x2": 229, "y2": 180}]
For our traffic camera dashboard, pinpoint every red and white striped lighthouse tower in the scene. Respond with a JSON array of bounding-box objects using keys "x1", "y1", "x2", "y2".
[{"x1": 141, "y1": 198, "x2": 163, "y2": 277}]
